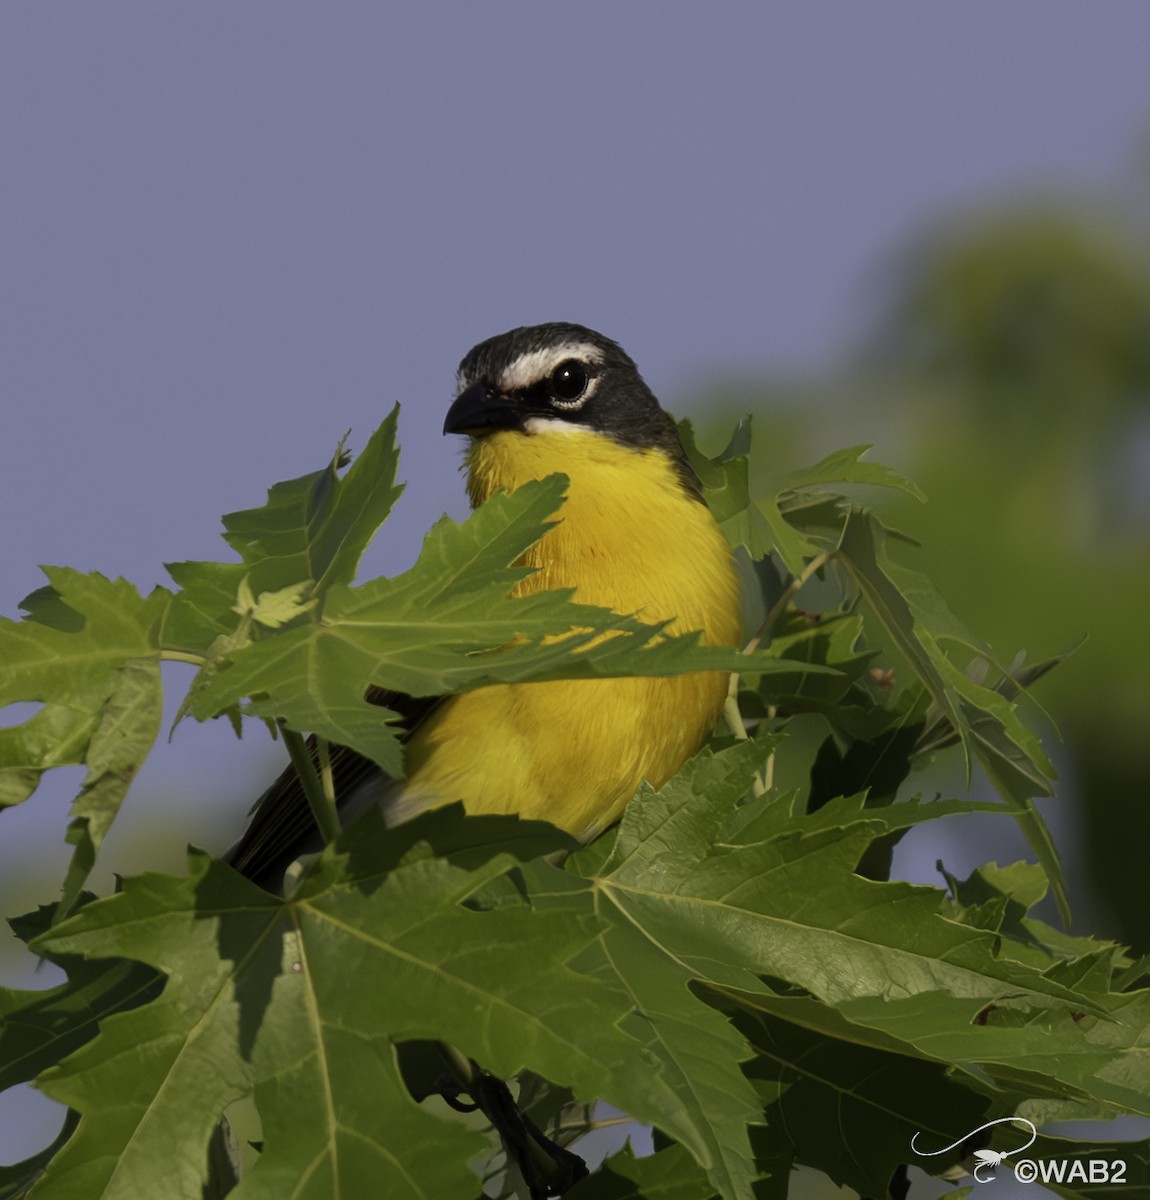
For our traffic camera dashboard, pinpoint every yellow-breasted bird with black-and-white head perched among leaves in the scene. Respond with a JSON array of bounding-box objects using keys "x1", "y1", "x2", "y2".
[{"x1": 226, "y1": 322, "x2": 741, "y2": 887}]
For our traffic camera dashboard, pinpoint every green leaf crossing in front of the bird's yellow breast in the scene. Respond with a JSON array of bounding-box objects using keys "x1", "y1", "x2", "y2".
[{"x1": 192, "y1": 475, "x2": 831, "y2": 773}]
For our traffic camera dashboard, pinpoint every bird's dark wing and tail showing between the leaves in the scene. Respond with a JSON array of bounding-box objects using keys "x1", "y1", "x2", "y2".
[{"x1": 223, "y1": 688, "x2": 442, "y2": 892}]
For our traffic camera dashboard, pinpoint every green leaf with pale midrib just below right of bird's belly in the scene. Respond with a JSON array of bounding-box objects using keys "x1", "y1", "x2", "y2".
[{"x1": 597, "y1": 746, "x2": 1097, "y2": 1010}]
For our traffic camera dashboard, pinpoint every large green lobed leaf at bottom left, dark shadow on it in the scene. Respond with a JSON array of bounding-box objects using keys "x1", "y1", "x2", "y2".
[{"x1": 27, "y1": 812, "x2": 710, "y2": 1200}]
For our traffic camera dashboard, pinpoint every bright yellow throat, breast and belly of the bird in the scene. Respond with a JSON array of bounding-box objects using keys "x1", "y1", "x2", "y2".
[{"x1": 391, "y1": 430, "x2": 739, "y2": 838}]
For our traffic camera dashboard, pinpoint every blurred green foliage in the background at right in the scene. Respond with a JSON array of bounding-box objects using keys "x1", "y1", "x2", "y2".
[{"x1": 696, "y1": 202, "x2": 1150, "y2": 950}]
